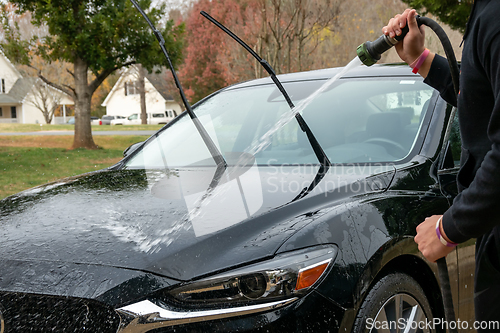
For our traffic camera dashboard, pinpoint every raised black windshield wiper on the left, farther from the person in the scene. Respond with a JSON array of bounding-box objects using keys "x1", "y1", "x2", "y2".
[{"x1": 130, "y1": 0, "x2": 227, "y2": 170}]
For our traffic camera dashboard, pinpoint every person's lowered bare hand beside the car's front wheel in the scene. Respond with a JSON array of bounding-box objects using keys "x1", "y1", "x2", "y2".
[{"x1": 415, "y1": 215, "x2": 454, "y2": 262}]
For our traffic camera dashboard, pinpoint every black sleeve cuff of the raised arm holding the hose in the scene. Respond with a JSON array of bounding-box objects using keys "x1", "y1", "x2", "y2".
[{"x1": 424, "y1": 54, "x2": 457, "y2": 106}]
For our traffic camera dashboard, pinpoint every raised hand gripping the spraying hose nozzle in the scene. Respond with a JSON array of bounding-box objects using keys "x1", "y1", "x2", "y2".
[{"x1": 382, "y1": 9, "x2": 425, "y2": 64}]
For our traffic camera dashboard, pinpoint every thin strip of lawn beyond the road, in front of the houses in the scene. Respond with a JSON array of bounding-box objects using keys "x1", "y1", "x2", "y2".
[{"x1": 0, "y1": 124, "x2": 163, "y2": 133}]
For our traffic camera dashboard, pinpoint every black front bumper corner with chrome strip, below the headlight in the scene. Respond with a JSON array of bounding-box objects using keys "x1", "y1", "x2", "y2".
[{"x1": 117, "y1": 291, "x2": 344, "y2": 333}]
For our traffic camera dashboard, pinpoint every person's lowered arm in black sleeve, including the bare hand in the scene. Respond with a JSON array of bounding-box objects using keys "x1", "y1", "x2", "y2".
[{"x1": 415, "y1": 19, "x2": 500, "y2": 261}]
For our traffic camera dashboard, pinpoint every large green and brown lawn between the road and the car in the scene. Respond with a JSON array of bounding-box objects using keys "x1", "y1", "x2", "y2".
[{"x1": 0, "y1": 136, "x2": 147, "y2": 199}]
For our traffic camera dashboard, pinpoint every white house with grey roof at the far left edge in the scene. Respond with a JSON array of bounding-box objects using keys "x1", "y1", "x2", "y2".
[{"x1": 0, "y1": 51, "x2": 74, "y2": 124}]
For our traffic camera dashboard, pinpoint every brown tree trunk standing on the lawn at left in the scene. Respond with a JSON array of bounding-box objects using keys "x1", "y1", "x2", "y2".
[{"x1": 72, "y1": 57, "x2": 98, "y2": 149}]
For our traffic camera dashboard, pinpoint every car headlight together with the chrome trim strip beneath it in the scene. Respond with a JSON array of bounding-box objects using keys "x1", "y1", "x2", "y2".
[{"x1": 116, "y1": 245, "x2": 338, "y2": 333}]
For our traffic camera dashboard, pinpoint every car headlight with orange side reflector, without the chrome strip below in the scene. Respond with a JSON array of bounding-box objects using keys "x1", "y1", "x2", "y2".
[{"x1": 168, "y1": 245, "x2": 337, "y2": 308}]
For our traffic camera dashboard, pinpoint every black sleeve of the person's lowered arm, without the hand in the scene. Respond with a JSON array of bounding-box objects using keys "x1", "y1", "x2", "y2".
[{"x1": 443, "y1": 33, "x2": 500, "y2": 243}]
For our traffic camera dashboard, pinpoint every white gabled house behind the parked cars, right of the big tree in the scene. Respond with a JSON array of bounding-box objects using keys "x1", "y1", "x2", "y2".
[{"x1": 102, "y1": 66, "x2": 182, "y2": 121}]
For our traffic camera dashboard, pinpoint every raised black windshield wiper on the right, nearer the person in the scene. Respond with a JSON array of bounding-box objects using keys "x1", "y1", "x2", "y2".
[{"x1": 200, "y1": 11, "x2": 332, "y2": 173}]
